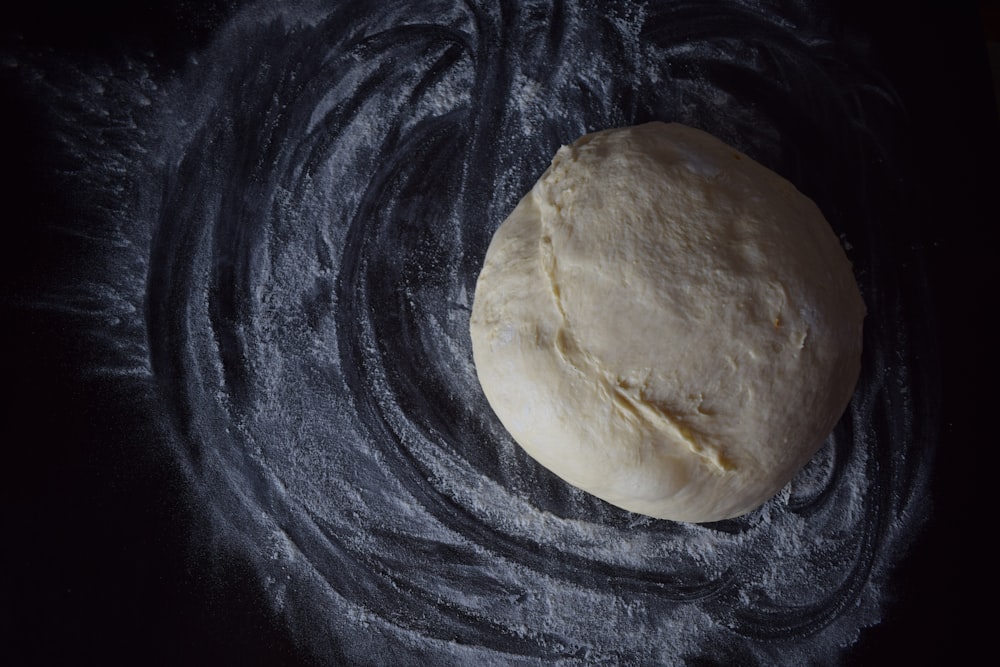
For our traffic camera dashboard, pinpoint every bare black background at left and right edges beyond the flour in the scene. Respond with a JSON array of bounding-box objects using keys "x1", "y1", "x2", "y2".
[{"x1": 0, "y1": 1, "x2": 1000, "y2": 665}]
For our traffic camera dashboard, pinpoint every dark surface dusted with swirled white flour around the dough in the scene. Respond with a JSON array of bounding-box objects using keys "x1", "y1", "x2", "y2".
[{"x1": 3, "y1": 2, "x2": 992, "y2": 664}]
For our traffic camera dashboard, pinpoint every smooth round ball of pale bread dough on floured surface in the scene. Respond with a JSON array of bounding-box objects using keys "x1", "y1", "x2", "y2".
[{"x1": 471, "y1": 123, "x2": 865, "y2": 522}]
